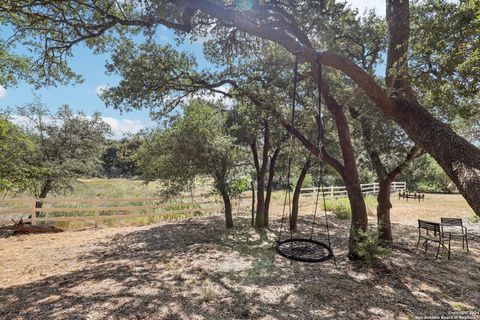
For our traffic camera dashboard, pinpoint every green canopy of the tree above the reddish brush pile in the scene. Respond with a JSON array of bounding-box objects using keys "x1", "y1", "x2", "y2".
[{"x1": 17, "y1": 102, "x2": 110, "y2": 198}]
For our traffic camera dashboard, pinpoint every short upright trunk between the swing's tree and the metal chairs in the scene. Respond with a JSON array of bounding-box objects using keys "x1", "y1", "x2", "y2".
[{"x1": 377, "y1": 179, "x2": 393, "y2": 242}]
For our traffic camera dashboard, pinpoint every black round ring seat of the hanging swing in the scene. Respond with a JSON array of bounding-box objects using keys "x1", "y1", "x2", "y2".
[{"x1": 275, "y1": 238, "x2": 333, "y2": 263}]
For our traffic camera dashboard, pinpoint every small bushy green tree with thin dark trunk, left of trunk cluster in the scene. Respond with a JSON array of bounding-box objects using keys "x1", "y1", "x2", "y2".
[{"x1": 138, "y1": 100, "x2": 244, "y2": 228}]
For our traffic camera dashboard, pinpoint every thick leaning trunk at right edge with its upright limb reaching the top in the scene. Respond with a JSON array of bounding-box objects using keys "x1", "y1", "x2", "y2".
[{"x1": 385, "y1": 0, "x2": 480, "y2": 216}]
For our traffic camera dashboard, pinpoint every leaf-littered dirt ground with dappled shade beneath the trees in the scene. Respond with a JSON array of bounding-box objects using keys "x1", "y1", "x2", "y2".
[{"x1": 0, "y1": 195, "x2": 480, "y2": 320}]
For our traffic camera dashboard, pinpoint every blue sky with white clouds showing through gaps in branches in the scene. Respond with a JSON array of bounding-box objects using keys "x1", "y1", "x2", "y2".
[{"x1": 0, "y1": 0, "x2": 385, "y2": 138}]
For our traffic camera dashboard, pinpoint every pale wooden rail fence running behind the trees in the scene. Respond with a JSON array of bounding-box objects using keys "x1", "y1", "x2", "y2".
[{"x1": 0, "y1": 182, "x2": 406, "y2": 226}]
